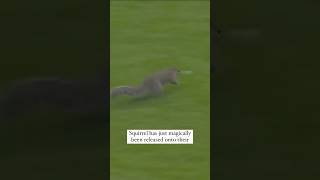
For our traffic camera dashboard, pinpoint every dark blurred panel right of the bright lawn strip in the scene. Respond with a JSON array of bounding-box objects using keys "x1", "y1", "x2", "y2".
[{"x1": 211, "y1": 0, "x2": 320, "y2": 180}]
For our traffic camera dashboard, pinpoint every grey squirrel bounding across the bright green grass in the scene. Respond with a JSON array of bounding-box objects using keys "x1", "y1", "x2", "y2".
[{"x1": 110, "y1": 67, "x2": 180, "y2": 97}]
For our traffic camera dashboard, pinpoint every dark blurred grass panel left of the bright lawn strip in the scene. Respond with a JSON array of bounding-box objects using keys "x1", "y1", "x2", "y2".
[{"x1": 0, "y1": 0, "x2": 109, "y2": 180}]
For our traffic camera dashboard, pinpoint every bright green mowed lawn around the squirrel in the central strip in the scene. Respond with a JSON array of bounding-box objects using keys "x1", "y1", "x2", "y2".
[{"x1": 110, "y1": 1, "x2": 210, "y2": 180}]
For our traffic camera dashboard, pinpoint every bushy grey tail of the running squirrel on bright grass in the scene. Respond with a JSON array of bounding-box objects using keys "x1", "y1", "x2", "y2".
[{"x1": 110, "y1": 86, "x2": 145, "y2": 97}]
